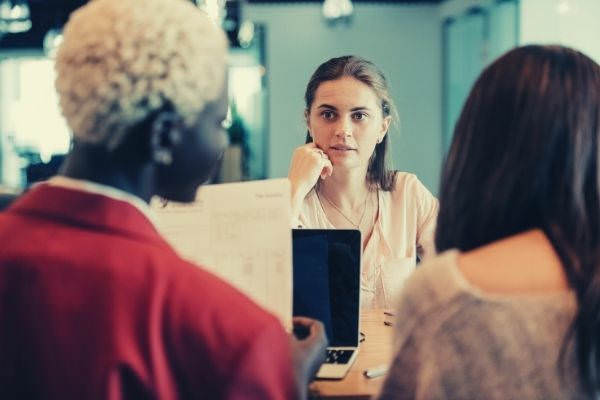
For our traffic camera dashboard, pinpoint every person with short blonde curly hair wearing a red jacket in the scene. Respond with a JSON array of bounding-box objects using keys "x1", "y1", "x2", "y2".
[{"x1": 0, "y1": 0, "x2": 326, "y2": 399}]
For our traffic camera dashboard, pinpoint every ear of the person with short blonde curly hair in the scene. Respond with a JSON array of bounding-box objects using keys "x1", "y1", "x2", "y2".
[{"x1": 150, "y1": 111, "x2": 181, "y2": 165}]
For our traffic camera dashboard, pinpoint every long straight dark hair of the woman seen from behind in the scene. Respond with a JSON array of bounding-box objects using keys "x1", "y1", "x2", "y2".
[{"x1": 436, "y1": 46, "x2": 600, "y2": 395}]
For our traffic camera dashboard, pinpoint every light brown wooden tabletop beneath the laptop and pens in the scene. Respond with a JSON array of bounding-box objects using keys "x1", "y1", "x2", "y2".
[{"x1": 310, "y1": 310, "x2": 394, "y2": 399}]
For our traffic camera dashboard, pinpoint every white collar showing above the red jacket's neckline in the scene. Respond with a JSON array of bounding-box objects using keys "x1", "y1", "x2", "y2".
[{"x1": 44, "y1": 175, "x2": 156, "y2": 227}]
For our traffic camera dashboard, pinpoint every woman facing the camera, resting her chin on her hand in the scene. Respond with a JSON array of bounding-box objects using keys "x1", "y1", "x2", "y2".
[{"x1": 289, "y1": 56, "x2": 438, "y2": 308}]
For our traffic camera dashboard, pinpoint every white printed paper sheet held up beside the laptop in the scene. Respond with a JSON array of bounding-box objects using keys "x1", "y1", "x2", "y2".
[{"x1": 152, "y1": 179, "x2": 292, "y2": 328}]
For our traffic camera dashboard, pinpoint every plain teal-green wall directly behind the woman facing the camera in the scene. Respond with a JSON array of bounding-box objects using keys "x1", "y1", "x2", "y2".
[{"x1": 244, "y1": 3, "x2": 442, "y2": 193}]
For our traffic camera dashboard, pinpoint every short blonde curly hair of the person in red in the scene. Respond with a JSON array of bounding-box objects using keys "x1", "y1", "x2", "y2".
[{"x1": 56, "y1": 0, "x2": 227, "y2": 150}]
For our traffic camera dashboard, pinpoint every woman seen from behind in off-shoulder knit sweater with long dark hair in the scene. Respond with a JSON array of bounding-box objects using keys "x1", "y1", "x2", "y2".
[{"x1": 381, "y1": 46, "x2": 600, "y2": 399}]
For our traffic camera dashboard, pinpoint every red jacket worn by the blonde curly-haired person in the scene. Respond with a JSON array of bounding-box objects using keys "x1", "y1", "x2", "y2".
[{"x1": 0, "y1": 185, "x2": 293, "y2": 399}]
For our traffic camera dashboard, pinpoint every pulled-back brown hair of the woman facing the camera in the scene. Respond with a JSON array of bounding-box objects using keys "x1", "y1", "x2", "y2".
[{"x1": 304, "y1": 56, "x2": 398, "y2": 191}]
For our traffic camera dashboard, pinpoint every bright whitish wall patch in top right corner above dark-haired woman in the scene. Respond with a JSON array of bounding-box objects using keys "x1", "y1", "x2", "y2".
[{"x1": 520, "y1": 0, "x2": 600, "y2": 62}]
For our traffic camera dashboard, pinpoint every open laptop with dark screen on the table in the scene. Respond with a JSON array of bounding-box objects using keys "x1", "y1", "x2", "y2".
[{"x1": 292, "y1": 229, "x2": 361, "y2": 379}]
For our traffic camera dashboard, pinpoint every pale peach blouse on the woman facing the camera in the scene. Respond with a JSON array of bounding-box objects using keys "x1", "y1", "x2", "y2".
[{"x1": 299, "y1": 172, "x2": 438, "y2": 309}]
